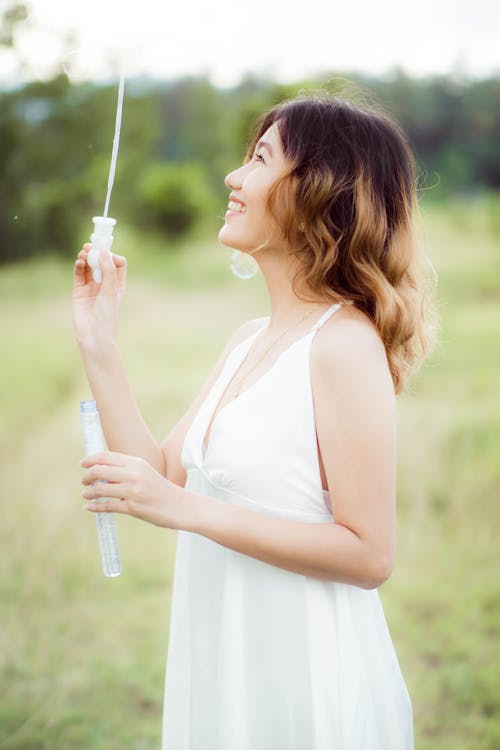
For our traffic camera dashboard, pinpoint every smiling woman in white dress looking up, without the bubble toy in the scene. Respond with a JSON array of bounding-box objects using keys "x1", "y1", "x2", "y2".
[{"x1": 74, "y1": 95, "x2": 438, "y2": 750}]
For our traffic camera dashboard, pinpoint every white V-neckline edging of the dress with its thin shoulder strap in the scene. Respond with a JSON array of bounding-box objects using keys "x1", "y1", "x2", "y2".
[{"x1": 200, "y1": 304, "x2": 344, "y2": 463}]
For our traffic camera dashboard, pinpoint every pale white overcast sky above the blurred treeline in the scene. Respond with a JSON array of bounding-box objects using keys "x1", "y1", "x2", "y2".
[{"x1": 0, "y1": 0, "x2": 500, "y2": 87}]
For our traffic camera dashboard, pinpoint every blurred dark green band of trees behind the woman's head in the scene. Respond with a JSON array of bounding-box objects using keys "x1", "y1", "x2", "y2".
[{"x1": 0, "y1": 67, "x2": 500, "y2": 263}]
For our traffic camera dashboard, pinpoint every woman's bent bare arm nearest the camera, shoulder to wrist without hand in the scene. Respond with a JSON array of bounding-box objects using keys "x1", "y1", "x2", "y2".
[{"x1": 182, "y1": 320, "x2": 396, "y2": 588}]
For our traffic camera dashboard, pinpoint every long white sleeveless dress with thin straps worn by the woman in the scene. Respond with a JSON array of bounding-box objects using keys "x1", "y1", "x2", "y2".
[{"x1": 162, "y1": 304, "x2": 413, "y2": 750}]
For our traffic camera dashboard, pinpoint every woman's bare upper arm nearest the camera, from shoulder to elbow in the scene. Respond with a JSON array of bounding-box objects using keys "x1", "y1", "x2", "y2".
[{"x1": 310, "y1": 307, "x2": 397, "y2": 588}]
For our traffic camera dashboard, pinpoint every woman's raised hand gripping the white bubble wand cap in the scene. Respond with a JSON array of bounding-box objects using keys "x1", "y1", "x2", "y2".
[{"x1": 73, "y1": 244, "x2": 127, "y2": 348}]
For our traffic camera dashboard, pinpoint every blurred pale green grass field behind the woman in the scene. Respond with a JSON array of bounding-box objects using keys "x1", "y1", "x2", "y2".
[{"x1": 0, "y1": 198, "x2": 500, "y2": 750}]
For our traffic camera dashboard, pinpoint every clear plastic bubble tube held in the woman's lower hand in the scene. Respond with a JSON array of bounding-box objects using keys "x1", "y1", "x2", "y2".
[{"x1": 80, "y1": 401, "x2": 121, "y2": 578}]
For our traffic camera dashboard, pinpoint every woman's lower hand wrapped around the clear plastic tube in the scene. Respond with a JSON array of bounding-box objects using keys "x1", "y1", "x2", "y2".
[{"x1": 80, "y1": 451, "x2": 186, "y2": 529}]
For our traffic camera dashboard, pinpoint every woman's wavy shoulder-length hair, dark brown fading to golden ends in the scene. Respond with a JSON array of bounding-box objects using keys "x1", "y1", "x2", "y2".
[{"x1": 245, "y1": 92, "x2": 438, "y2": 394}]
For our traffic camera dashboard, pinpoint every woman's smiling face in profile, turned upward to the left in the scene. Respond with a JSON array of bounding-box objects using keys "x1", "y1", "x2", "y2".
[{"x1": 219, "y1": 122, "x2": 286, "y2": 252}]
